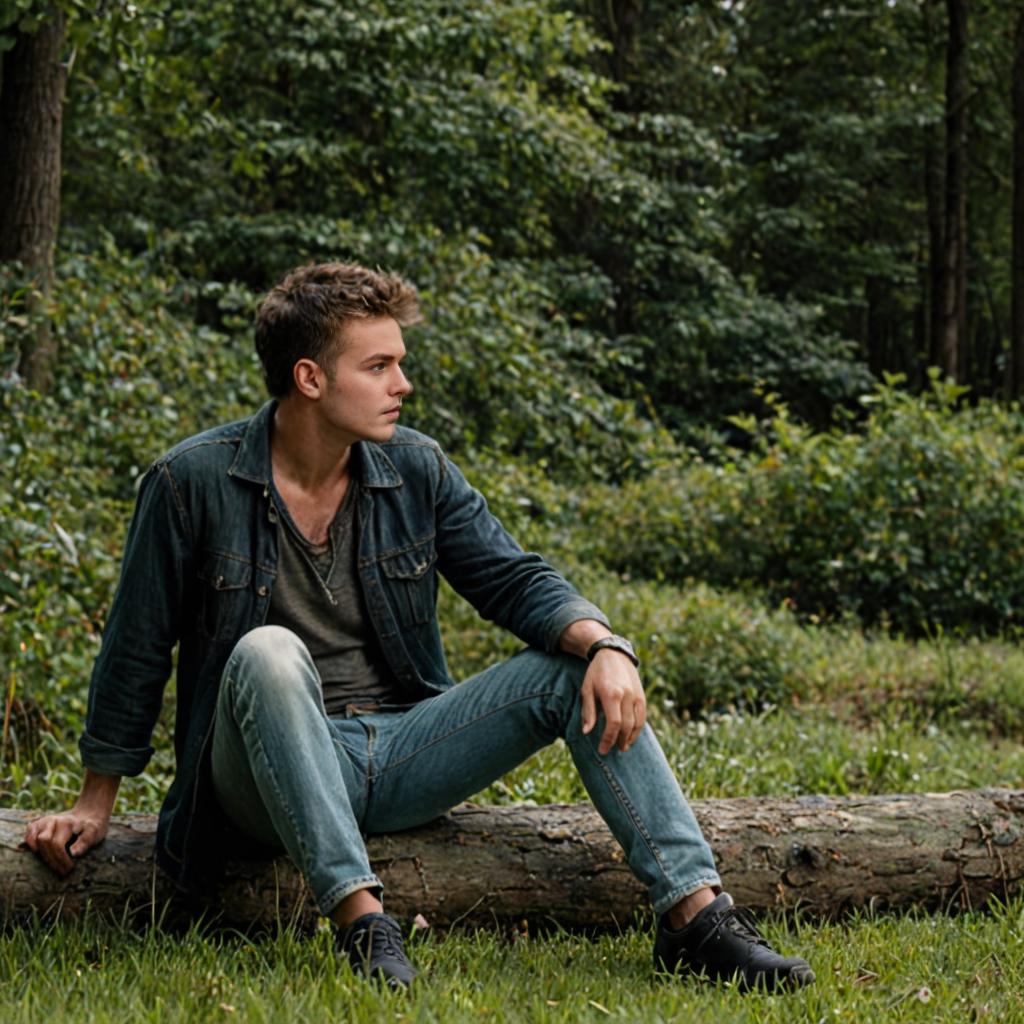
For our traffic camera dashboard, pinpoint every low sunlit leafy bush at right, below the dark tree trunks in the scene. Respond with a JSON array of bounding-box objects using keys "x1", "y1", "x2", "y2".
[{"x1": 581, "y1": 379, "x2": 1024, "y2": 633}]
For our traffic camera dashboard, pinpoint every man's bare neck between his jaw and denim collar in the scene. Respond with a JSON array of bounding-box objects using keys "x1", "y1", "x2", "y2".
[{"x1": 270, "y1": 397, "x2": 352, "y2": 494}]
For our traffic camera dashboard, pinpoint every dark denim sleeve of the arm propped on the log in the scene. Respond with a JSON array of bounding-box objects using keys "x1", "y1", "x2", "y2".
[{"x1": 79, "y1": 463, "x2": 190, "y2": 775}]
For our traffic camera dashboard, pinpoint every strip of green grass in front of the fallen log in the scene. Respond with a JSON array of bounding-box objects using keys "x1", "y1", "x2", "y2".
[{"x1": 0, "y1": 902, "x2": 1024, "y2": 1024}]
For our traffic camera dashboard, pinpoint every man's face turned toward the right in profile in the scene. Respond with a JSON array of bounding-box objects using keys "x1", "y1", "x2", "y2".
[{"x1": 318, "y1": 317, "x2": 413, "y2": 444}]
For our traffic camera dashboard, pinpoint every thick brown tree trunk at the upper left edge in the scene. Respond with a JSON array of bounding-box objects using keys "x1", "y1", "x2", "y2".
[{"x1": 0, "y1": 8, "x2": 67, "y2": 391}]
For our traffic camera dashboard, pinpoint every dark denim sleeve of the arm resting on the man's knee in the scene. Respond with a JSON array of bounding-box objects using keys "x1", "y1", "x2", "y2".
[{"x1": 436, "y1": 456, "x2": 608, "y2": 652}]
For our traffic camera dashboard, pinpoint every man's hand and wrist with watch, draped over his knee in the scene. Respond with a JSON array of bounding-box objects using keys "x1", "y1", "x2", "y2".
[{"x1": 559, "y1": 618, "x2": 647, "y2": 754}]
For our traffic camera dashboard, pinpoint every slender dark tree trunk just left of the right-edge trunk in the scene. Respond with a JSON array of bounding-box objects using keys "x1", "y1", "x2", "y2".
[{"x1": 936, "y1": 0, "x2": 968, "y2": 380}]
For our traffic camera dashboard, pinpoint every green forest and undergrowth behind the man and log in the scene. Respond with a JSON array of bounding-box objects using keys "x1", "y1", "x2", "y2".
[{"x1": 0, "y1": 0, "x2": 1024, "y2": 1020}]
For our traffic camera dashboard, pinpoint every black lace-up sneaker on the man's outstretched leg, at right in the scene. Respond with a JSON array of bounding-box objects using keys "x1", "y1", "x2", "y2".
[{"x1": 654, "y1": 893, "x2": 814, "y2": 990}]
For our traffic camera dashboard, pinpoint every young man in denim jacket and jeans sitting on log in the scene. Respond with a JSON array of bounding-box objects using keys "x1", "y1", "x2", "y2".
[{"x1": 27, "y1": 263, "x2": 814, "y2": 988}]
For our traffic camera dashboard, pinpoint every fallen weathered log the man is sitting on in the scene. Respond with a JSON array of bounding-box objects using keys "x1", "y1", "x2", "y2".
[{"x1": 0, "y1": 790, "x2": 1024, "y2": 930}]
